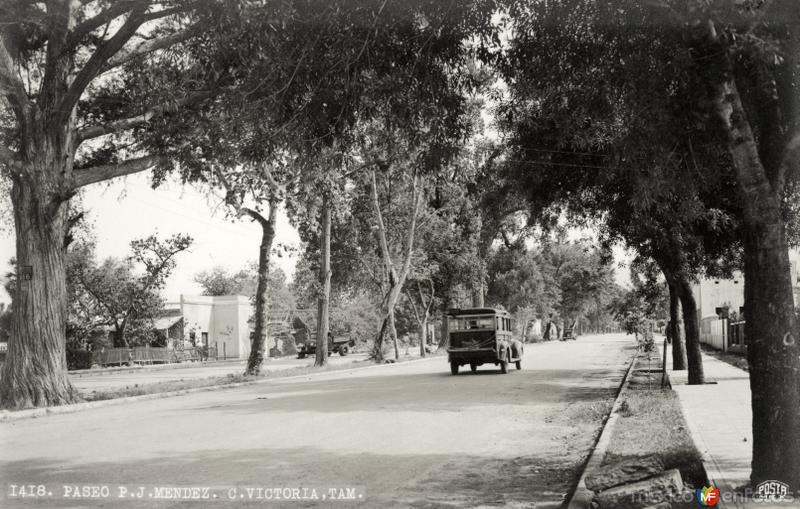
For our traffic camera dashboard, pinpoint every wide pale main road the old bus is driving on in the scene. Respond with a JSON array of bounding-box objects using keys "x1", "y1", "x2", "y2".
[{"x1": 0, "y1": 335, "x2": 632, "y2": 509}]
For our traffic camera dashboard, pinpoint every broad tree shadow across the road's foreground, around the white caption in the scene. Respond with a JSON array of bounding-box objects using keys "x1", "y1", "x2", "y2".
[{"x1": 0, "y1": 448, "x2": 578, "y2": 508}]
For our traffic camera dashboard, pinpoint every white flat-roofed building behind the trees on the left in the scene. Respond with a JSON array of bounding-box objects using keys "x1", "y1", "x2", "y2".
[{"x1": 167, "y1": 295, "x2": 252, "y2": 359}]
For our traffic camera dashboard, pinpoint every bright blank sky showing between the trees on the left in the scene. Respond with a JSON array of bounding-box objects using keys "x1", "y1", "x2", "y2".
[{"x1": 0, "y1": 172, "x2": 300, "y2": 303}]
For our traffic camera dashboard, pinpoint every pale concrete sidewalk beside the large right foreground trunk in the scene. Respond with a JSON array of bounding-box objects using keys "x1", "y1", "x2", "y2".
[{"x1": 667, "y1": 347, "x2": 753, "y2": 508}]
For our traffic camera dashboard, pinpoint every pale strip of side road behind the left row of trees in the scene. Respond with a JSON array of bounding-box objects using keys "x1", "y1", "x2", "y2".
[{"x1": 70, "y1": 353, "x2": 367, "y2": 393}]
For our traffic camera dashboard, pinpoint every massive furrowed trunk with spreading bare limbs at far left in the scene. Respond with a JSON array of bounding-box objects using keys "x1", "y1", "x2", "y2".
[{"x1": 0, "y1": 2, "x2": 209, "y2": 408}]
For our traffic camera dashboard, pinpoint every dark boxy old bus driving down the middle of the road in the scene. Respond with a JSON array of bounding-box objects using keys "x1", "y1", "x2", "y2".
[{"x1": 447, "y1": 308, "x2": 523, "y2": 375}]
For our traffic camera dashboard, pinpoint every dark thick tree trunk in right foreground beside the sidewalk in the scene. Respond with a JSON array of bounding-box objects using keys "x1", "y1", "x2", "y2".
[{"x1": 726, "y1": 76, "x2": 800, "y2": 490}]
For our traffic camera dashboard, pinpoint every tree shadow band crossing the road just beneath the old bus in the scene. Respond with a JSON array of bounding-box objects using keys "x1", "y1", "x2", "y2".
[{"x1": 174, "y1": 370, "x2": 620, "y2": 414}]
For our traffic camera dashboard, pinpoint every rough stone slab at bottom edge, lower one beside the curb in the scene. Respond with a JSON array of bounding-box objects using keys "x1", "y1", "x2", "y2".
[{"x1": 594, "y1": 469, "x2": 684, "y2": 509}]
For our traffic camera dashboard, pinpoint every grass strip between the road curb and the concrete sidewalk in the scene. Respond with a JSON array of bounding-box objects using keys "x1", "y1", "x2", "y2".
[{"x1": 603, "y1": 354, "x2": 705, "y2": 487}]
